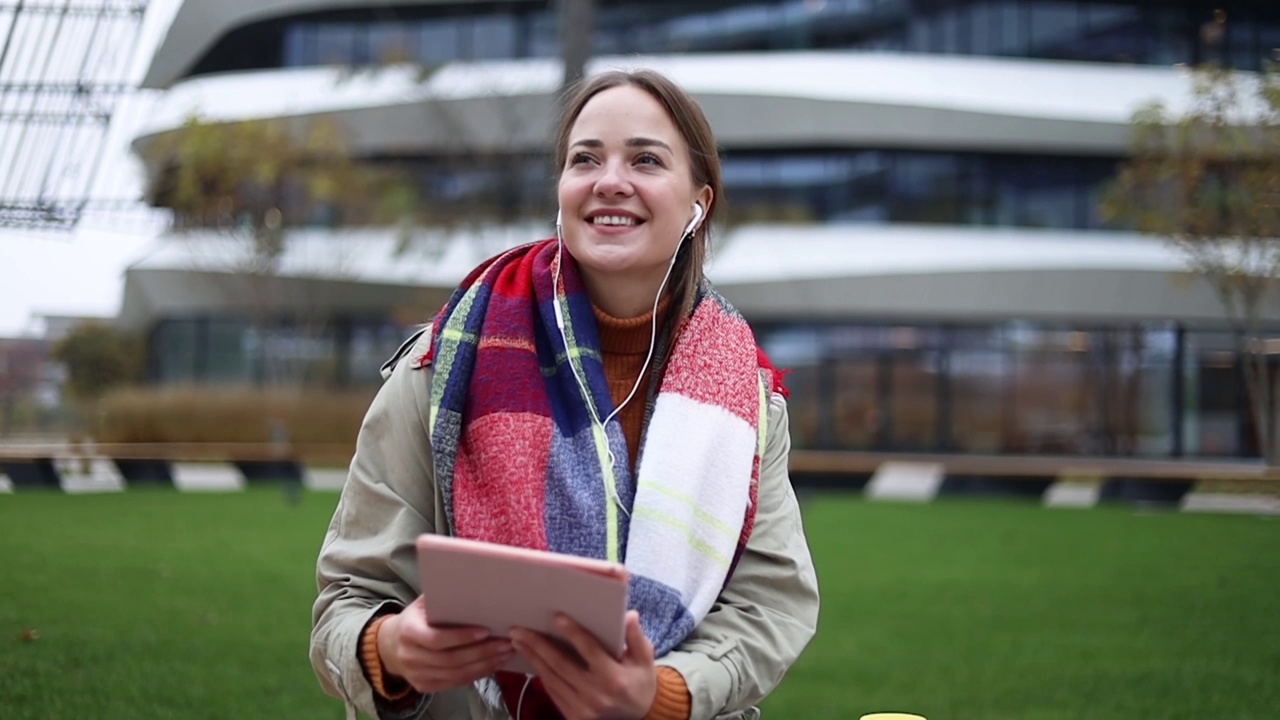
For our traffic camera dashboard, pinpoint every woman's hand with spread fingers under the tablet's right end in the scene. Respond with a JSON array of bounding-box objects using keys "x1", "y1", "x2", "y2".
[{"x1": 511, "y1": 610, "x2": 658, "y2": 720}]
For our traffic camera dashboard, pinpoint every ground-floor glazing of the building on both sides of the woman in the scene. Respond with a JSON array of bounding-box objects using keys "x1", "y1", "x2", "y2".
[{"x1": 150, "y1": 311, "x2": 1264, "y2": 457}]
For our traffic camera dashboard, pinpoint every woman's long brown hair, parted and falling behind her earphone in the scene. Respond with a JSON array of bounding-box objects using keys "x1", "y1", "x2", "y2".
[{"x1": 556, "y1": 70, "x2": 724, "y2": 316}]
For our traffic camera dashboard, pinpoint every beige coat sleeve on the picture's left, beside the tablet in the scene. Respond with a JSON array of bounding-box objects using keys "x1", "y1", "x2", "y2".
[{"x1": 311, "y1": 330, "x2": 435, "y2": 720}]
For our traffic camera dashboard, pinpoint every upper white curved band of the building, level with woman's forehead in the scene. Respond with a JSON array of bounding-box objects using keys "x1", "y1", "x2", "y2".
[{"x1": 136, "y1": 51, "x2": 1189, "y2": 172}]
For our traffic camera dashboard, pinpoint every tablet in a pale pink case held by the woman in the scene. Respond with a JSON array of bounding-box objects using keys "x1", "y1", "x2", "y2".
[{"x1": 417, "y1": 534, "x2": 627, "y2": 674}]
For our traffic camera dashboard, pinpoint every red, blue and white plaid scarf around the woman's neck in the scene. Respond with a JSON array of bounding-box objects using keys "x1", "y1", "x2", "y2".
[{"x1": 430, "y1": 240, "x2": 769, "y2": 712}]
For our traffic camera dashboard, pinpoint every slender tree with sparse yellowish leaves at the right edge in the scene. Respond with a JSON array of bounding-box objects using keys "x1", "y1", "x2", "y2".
[{"x1": 1102, "y1": 65, "x2": 1280, "y2": 464}]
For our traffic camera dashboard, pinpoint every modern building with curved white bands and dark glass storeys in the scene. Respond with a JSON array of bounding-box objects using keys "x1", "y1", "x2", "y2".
[{"x1": 122, "y1": 0, "x2": 1280, "y2": 457}]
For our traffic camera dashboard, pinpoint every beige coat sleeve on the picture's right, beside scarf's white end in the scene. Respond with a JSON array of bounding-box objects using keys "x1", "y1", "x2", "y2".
[{"x1": 658, "y1": 393, "x2": 818, "y2": 720}]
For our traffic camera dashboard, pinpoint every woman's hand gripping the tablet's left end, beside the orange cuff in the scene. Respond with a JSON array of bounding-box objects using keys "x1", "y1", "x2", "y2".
[{"x1": 378, "y1": 596, "x2": 515, "y2": 693}]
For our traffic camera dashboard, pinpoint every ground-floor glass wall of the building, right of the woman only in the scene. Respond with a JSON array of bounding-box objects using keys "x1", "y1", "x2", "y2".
[{"x1": 764, "y1": 322, "x2": 1249, "y2": 457}]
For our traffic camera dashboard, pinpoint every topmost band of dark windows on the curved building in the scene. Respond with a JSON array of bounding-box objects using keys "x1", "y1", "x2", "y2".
[{"x1": 193, "y1": 0, "x2": 1280, "y2": 74}]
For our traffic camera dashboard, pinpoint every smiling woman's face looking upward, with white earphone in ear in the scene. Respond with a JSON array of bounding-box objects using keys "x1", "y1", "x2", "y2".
[{"x1": 558, "y1": 86, "x2": 712, "y2": 291}]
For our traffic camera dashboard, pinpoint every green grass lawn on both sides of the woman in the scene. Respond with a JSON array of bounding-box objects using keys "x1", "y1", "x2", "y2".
[{"x1": 0, "y1": 489, "x2": 1280, "y2": 720}]
